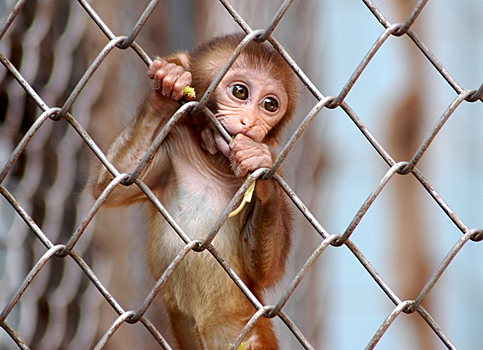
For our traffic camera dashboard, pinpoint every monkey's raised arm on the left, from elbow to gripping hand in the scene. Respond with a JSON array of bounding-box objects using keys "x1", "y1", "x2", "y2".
[{"x1": 91, "y1": 54, "x2": 193, "y2": 205}]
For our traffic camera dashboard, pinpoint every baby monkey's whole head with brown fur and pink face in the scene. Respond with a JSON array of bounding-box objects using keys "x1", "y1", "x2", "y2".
[{"x1": 189, "y1": 34, "x2": 298, "y2": 147}]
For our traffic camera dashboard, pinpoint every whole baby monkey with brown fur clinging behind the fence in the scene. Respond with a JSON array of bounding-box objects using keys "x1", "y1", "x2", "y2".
[{"x1": 92, "y1": 34, "x2": 297, "y2": 350}]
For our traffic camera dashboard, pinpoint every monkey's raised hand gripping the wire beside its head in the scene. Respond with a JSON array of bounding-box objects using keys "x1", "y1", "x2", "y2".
[{"x1": 148, "y1": 58, "x2": 195, "y2": 110}]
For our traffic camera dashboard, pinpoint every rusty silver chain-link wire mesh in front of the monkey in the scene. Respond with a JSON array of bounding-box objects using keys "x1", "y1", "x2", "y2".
[{"x1": 0, "y1": 0, "x2": 483, "y2": 349}]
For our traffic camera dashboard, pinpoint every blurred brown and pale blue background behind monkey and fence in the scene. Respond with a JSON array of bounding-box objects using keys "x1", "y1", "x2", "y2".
[{"x1": 0, "y1": 0, "x2": 483, "y2": 350}]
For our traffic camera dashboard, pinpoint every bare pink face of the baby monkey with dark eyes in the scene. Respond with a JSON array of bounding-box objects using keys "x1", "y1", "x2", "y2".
[{"x1": 205, "y1": 70, "x2": 288, "y2": 155}]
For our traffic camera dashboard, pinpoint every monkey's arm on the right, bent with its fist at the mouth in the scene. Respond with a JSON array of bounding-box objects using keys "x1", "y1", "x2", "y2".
[{"x1": 229, "y1": 134, "x2": 292, "y2": 287}]
